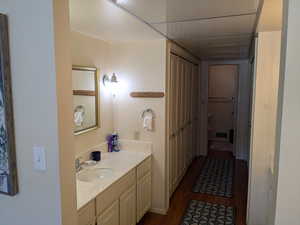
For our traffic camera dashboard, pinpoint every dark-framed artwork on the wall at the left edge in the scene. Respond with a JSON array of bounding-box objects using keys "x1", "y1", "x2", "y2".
[{"x1": 0, "y1": 14, "x2": 18, "y2": 196}]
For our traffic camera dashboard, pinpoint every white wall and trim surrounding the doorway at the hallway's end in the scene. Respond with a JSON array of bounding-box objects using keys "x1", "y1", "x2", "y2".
[{"x1": 200, "y1": 60, "x2": 251, "y2": 160}]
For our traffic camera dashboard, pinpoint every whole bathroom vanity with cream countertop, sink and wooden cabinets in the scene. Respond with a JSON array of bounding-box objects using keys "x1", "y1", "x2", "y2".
[{"x1": 77, "y1": 151, "x2": 151, "y2": 225}]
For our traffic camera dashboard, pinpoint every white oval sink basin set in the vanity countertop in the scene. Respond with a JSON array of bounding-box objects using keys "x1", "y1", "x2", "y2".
[{"x1": 77, "y1": 168, "x2": 113, "y2": 182}]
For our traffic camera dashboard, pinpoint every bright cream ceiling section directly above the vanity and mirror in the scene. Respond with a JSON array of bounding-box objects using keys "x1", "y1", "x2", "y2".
[{"x1": 70, "y1": 0, "x2": 163, "y2": 41}]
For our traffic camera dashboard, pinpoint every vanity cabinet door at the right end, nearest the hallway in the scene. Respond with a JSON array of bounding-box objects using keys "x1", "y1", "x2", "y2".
[{"x1": 137, "y1": 172, "x2": 151, "y2": 222}]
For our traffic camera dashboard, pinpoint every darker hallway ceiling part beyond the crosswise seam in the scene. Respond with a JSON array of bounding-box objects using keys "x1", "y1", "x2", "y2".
[{"x1": 153, "y1": 15, "x2": 256, "y2": 58}]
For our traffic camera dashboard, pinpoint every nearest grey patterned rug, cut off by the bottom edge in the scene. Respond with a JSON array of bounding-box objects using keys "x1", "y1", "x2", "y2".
[{"x1": 181, "y1": 200, "x2": 235, "y2": 225}]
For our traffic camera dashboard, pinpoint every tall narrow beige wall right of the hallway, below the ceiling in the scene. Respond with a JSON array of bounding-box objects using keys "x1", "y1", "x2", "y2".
[{"x1": 248, "y1": 31, "x2": 281, "y2": 225}]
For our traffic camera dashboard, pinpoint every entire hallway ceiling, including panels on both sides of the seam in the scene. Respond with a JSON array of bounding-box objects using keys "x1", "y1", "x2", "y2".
[{"x1": 112, "y1": 0, "x2": 259, "y2": 59}]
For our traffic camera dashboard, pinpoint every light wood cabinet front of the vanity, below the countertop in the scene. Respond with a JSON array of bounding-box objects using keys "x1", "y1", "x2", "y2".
[{"x1": 78, "y1": 157, "x2": 151, "y2": 225}]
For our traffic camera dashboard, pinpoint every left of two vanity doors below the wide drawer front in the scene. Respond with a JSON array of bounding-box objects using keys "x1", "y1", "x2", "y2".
[{"x1": 97, "y1": 200, "x2": 120, "y2": 225}]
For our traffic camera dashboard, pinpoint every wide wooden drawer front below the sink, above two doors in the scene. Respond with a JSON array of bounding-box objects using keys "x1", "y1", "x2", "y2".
[{"x1": 96, "y1": 169, "x2": 136, "y2": 215}]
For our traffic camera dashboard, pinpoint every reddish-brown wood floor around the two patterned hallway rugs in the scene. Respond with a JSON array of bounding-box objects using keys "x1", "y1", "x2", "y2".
[{"x1": 138, "y1": 151, "x2": 248, "y2": 225}]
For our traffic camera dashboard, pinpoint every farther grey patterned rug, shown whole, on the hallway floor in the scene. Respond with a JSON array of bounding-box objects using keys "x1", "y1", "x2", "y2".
[{"x1": 193, "y1": 158, "x2": 234, "y2": 198}]
